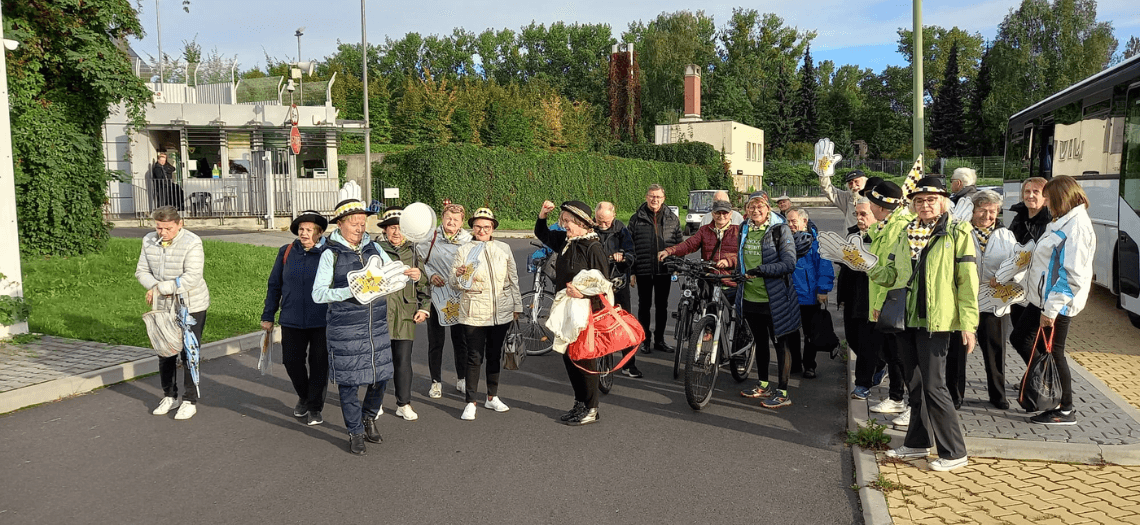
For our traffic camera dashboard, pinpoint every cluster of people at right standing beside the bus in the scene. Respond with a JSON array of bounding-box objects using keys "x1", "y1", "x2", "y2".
[{"x1": 821, "y1": 169, "x2": 1096, "y2": 470}]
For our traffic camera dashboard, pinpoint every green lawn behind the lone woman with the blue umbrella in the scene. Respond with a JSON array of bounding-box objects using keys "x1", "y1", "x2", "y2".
[{"x1": 22, "y1": 238, "x2": 277, "y2": 347}]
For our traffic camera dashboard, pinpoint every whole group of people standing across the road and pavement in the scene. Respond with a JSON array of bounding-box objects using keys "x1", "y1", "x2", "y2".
[{"x1": 136, "y1": 166, "x2": 1094, "y2": 462}]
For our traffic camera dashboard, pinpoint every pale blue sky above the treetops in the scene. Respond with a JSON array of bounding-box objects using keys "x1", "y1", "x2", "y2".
[{"x1": 131, "y1": 0, "x2": 1140, "y2": 75}]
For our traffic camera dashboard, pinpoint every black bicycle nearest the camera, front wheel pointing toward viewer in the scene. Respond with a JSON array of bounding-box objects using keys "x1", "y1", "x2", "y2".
[{"x1": 666, "y1": 257, "x2": 756, "y2": 410}]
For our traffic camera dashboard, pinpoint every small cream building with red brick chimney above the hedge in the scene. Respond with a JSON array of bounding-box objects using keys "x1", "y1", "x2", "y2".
[{"x1": 653, "y1": 64, "x2": 764, "y2": 191}]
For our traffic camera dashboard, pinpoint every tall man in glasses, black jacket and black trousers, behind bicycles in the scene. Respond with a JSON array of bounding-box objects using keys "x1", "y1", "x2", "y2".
[{"x1": 628, "y1": 184, "x2": 682, "y2": 354}]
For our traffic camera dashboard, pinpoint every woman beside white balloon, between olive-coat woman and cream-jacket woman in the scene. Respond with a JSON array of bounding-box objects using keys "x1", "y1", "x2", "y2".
[{"x1": 416, "y1": 204, "x2": 471, "y2": 399}]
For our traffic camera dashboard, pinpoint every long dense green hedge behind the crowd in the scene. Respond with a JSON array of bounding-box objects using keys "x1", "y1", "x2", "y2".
[{"x1": 373, "y1": 145, "x2": 710, "y2": 220}]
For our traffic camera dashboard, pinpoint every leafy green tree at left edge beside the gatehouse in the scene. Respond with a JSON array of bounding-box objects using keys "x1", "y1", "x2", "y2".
[{"x1": 2, "y1": 0, "x2": 152, "y2": 255}]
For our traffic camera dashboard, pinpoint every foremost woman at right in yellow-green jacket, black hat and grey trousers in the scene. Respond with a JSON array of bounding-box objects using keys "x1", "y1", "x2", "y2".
[{"x1": 868, "y1": 177, "x2": 978, "y2": 471}]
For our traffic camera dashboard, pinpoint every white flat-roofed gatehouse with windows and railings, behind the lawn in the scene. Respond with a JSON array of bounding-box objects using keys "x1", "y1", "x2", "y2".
[{"x1": 103, "y1": 53, "x2": 363, "y2": 228}]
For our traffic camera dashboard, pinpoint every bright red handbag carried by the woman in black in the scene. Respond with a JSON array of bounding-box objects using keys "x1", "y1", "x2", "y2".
[{"x1": 567, "y1": 294, "x2": 645, "y2": 374}]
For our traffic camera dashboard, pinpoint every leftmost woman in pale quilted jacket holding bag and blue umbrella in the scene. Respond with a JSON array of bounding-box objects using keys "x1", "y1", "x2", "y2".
[{"x1": 135, "y1": 206, "x2": 210, "y2": 419}]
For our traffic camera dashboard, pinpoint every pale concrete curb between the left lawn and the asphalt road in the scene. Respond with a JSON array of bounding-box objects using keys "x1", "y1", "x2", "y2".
[{"x1": 0, "y1": 328, "x2": 280, "y2": 413}]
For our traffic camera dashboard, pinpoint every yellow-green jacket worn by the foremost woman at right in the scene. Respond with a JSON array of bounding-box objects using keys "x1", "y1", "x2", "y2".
[{"x1": 868, "y1": 213, "x2": 978, "y2": 331}]
